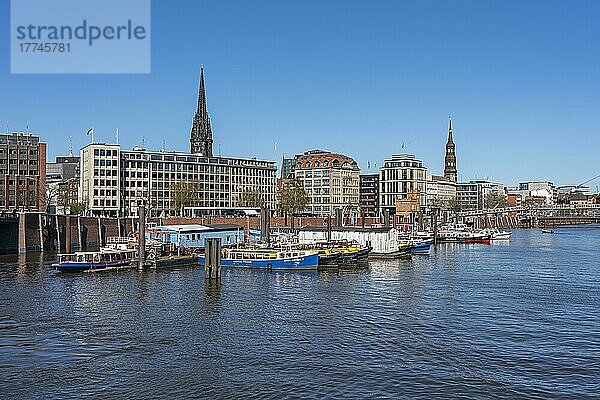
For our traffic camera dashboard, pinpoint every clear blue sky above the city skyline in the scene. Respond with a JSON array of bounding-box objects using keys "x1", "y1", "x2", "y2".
[{"x1": 0, "y1": 0, "x2": 600, "y2": 187}]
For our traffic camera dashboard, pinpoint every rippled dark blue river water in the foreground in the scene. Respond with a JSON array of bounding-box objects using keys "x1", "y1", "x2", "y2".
[{"x1": 0, "y1": 227, "x2": 600, "y2": 399}]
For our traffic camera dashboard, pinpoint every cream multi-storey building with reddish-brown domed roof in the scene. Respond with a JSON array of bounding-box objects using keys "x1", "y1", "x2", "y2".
[{"x1": 293, "y1": 150, "x2": 360, "y2": 216}]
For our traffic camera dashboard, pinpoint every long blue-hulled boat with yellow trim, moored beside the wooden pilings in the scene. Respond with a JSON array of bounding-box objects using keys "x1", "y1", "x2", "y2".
[{"x1": 198, "y1": 249, "x2": 319, "y2": 270}]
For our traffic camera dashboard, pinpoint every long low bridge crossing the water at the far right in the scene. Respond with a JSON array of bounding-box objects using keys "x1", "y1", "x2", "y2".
[{"x1": 455, "y1": 204, "x2": 600, "y2": 228}]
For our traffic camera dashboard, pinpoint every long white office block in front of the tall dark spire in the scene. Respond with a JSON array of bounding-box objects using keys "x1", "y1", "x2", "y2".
[{"x1": 81, "y1": 143, "x2": 277, "y2": 217}]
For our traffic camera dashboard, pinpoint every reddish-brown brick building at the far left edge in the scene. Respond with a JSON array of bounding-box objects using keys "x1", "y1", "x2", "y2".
[{"x1": 0, "y1": 132, "x2": 46, "y2": 212}]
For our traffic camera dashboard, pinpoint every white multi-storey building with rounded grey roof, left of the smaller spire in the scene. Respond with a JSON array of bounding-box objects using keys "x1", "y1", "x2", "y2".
[{"x1": 379, "y1": 154, "x2": 427, "y2": 214}]
